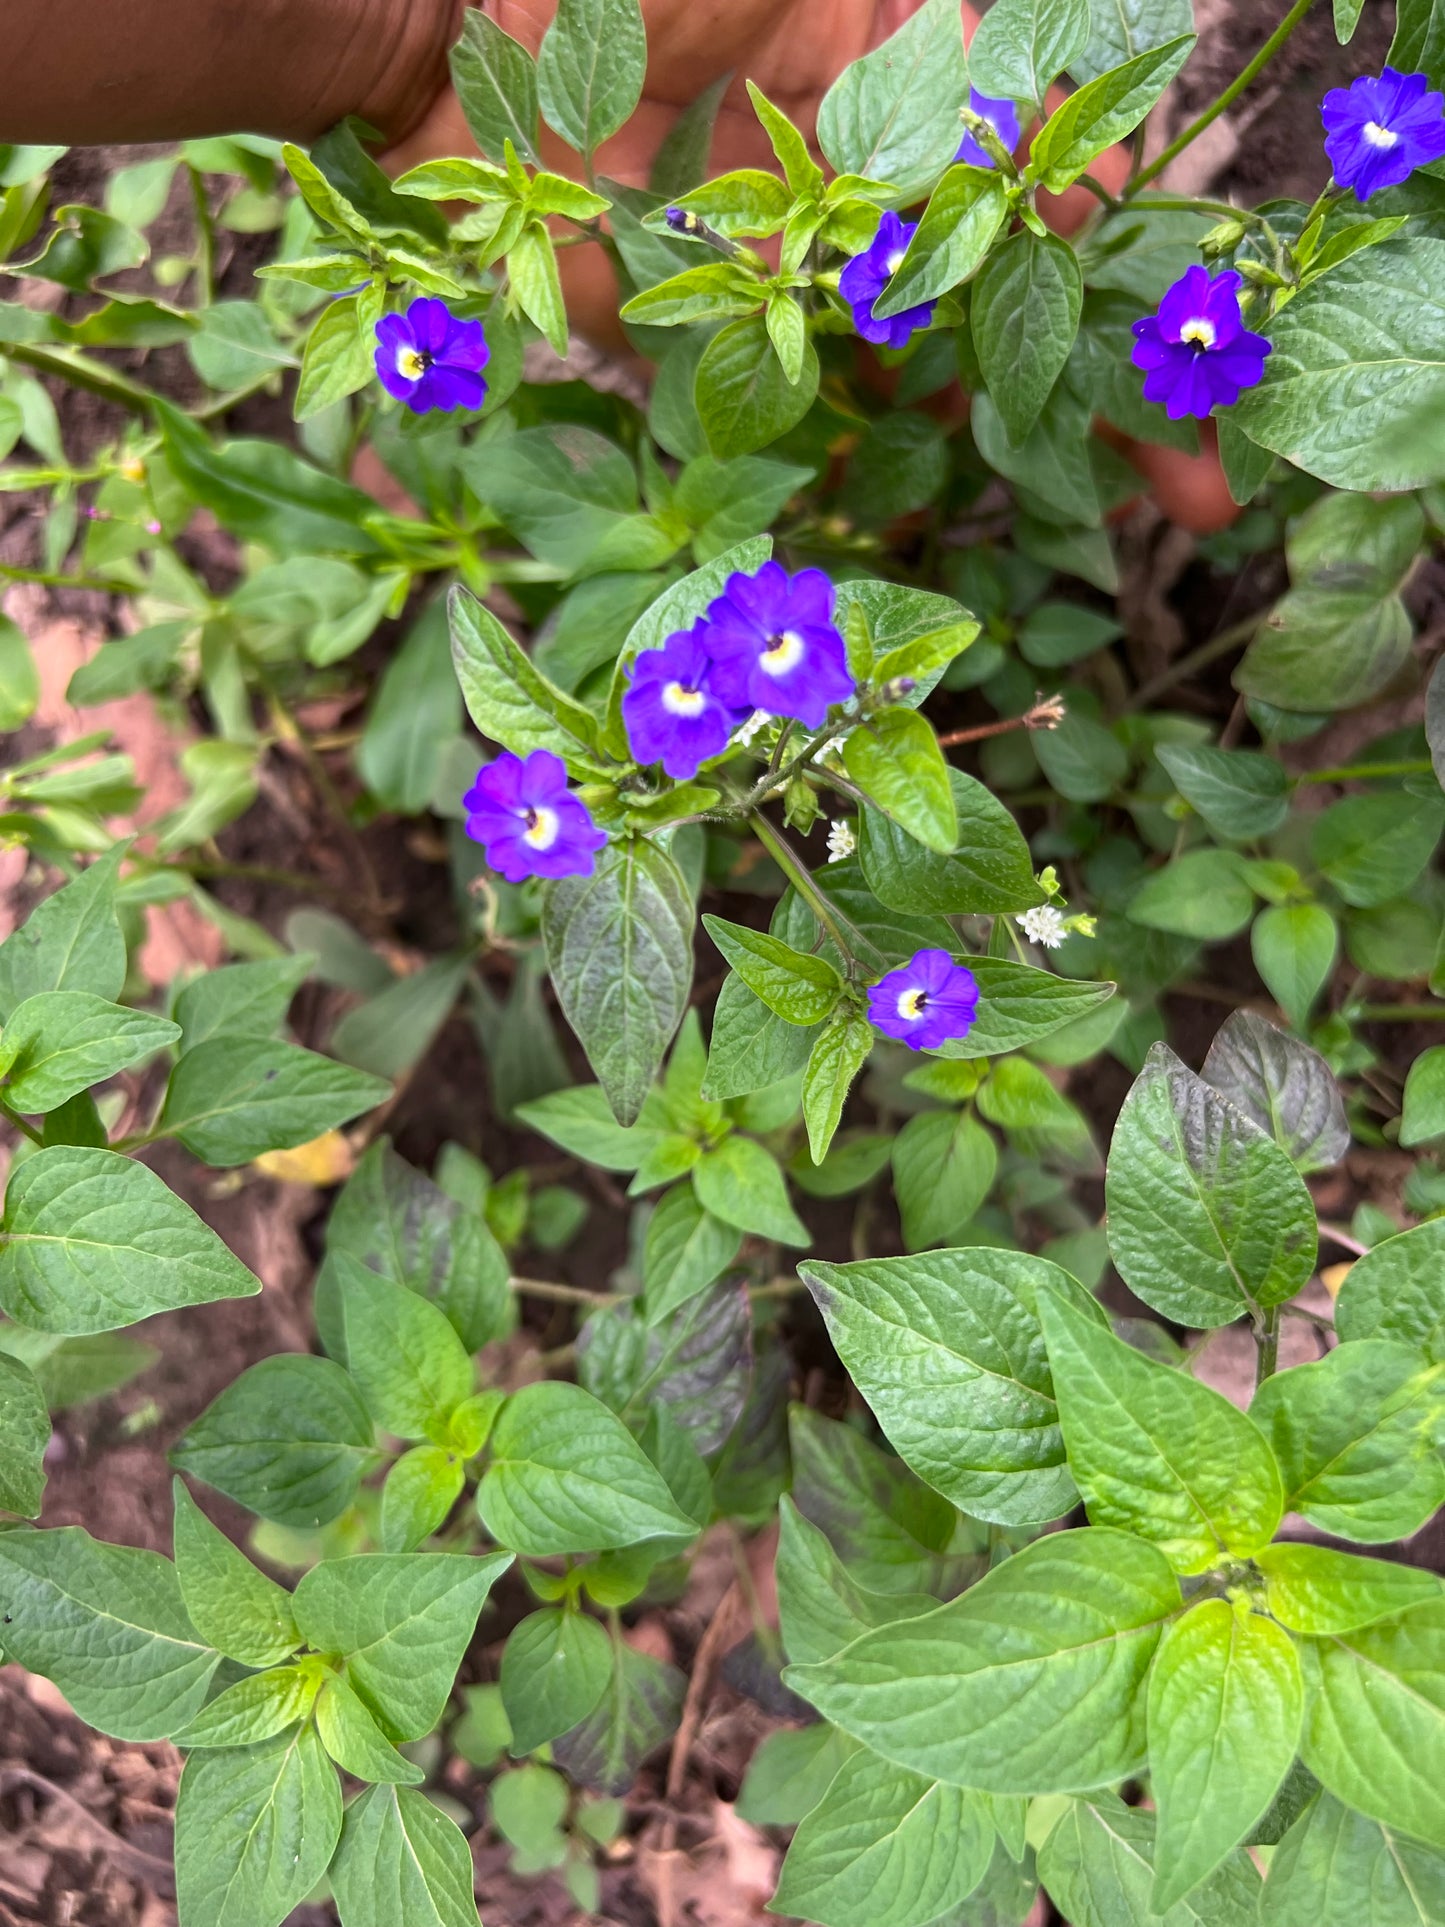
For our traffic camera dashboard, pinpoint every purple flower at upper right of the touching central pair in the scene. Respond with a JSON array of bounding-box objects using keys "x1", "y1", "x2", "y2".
[{"x1": 699, "y1": 563, "x2": 854, "y2": 728}]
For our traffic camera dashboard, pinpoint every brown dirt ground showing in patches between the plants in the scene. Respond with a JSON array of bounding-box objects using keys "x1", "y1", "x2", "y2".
[{"x1": 0, "y1": 0, "x2": 1445, "y2": 1927}]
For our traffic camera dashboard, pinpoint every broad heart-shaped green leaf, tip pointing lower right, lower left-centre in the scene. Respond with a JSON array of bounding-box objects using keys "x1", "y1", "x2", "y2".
[{"x1": 476, "y1": 1384, "x2": 696, "y2": 1559}]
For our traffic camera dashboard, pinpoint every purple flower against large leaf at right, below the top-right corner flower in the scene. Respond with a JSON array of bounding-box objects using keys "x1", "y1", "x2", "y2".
[{"x1": 1133, "y1": 268, "x2": 1270, "y2": 422}]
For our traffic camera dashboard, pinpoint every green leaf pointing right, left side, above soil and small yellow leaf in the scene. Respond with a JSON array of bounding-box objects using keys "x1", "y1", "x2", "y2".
[{"x1": 160, "y1": 1037, "x2": 391, "y2": 1166}]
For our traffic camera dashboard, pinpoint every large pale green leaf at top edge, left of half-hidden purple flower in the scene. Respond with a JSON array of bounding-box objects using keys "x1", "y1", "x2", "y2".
[{"x1": 817, "y1": 0, "x2": 969, "y2": 198}]
